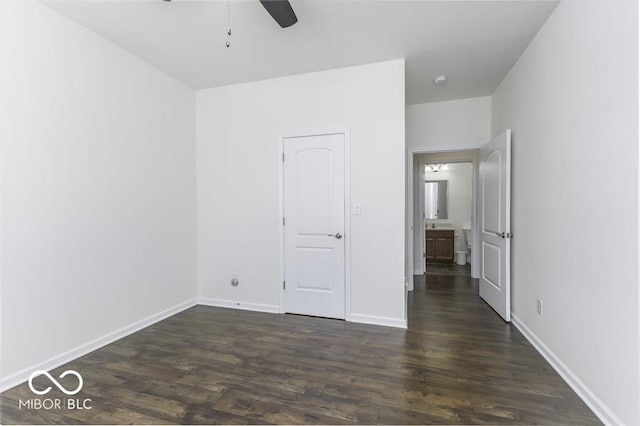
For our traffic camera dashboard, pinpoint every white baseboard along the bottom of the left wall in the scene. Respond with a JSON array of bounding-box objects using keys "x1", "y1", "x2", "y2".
[{"x1": 0, "y1": 299, "x2": 196, "y2": 392}]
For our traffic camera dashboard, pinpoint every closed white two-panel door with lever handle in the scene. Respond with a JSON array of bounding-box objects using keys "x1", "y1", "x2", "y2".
[{"x1": 284, "y1": 134, "x2": 345, "y2": 319}]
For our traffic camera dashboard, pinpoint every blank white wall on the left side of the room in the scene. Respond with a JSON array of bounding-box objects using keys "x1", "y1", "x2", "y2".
[{"x1": 0, "y1": 0, "x2": 196, "y2": 386}]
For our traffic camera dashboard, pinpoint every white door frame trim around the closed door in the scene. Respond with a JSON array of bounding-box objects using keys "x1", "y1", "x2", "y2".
[{"x1": 277, "y1": 128, "x2": 351, "y2": 321}]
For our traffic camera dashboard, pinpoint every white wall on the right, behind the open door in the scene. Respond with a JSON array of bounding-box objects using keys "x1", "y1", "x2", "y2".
[{"x1": 492, "y1": 0, "x2": 640, "y2": 425}]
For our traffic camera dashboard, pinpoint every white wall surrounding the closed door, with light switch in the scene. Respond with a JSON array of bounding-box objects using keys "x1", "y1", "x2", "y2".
[{"x1": 197, "y1": 60, "x2": 405, "y2": 325}]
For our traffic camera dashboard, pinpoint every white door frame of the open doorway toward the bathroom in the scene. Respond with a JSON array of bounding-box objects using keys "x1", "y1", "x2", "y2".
[{"x1": 406, "y1": 146, "x2": 480, "y2": 291}]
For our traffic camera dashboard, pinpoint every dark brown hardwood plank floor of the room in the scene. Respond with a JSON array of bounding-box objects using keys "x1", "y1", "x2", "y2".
[{"x1": 0, "y1": 275, "x2": 599, "y2": 425}]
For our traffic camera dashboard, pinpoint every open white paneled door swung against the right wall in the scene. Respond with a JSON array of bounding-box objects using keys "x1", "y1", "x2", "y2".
[{"x1": 478, "y1": 130, "x2": 512, "y2": 322}]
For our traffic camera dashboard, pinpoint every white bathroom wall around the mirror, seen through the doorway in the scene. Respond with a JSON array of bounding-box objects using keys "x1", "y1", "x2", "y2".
[{"x1": 416, "y1": 161, "x2": 473, "y2": 251}]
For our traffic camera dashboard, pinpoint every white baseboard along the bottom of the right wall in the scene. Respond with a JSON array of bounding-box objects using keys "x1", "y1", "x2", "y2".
[{"x1": 511, "y1": 313, "x2": 623, "y2": 426}]
